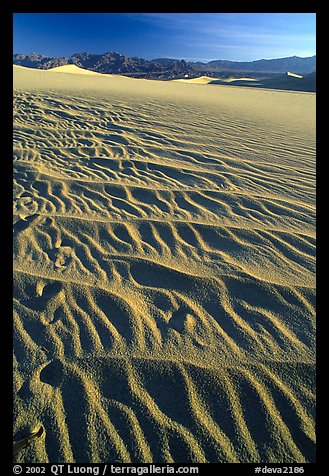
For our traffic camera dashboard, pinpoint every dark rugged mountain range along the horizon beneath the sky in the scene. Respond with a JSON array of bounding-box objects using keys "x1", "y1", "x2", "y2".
[{"x1": 13, "y1": 52, "x2": 316, "y2": 78}]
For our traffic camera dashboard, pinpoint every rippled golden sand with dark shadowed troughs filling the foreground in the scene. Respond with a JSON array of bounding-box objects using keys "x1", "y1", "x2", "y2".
[{"x1": 13, "y1": 67, "x2": 315, "y2": 463}]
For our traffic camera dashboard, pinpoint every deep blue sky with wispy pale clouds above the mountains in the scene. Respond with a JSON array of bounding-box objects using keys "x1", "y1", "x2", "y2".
[{"x1": 14, "y1": 13, "x2": 316, "y2": 61}]
